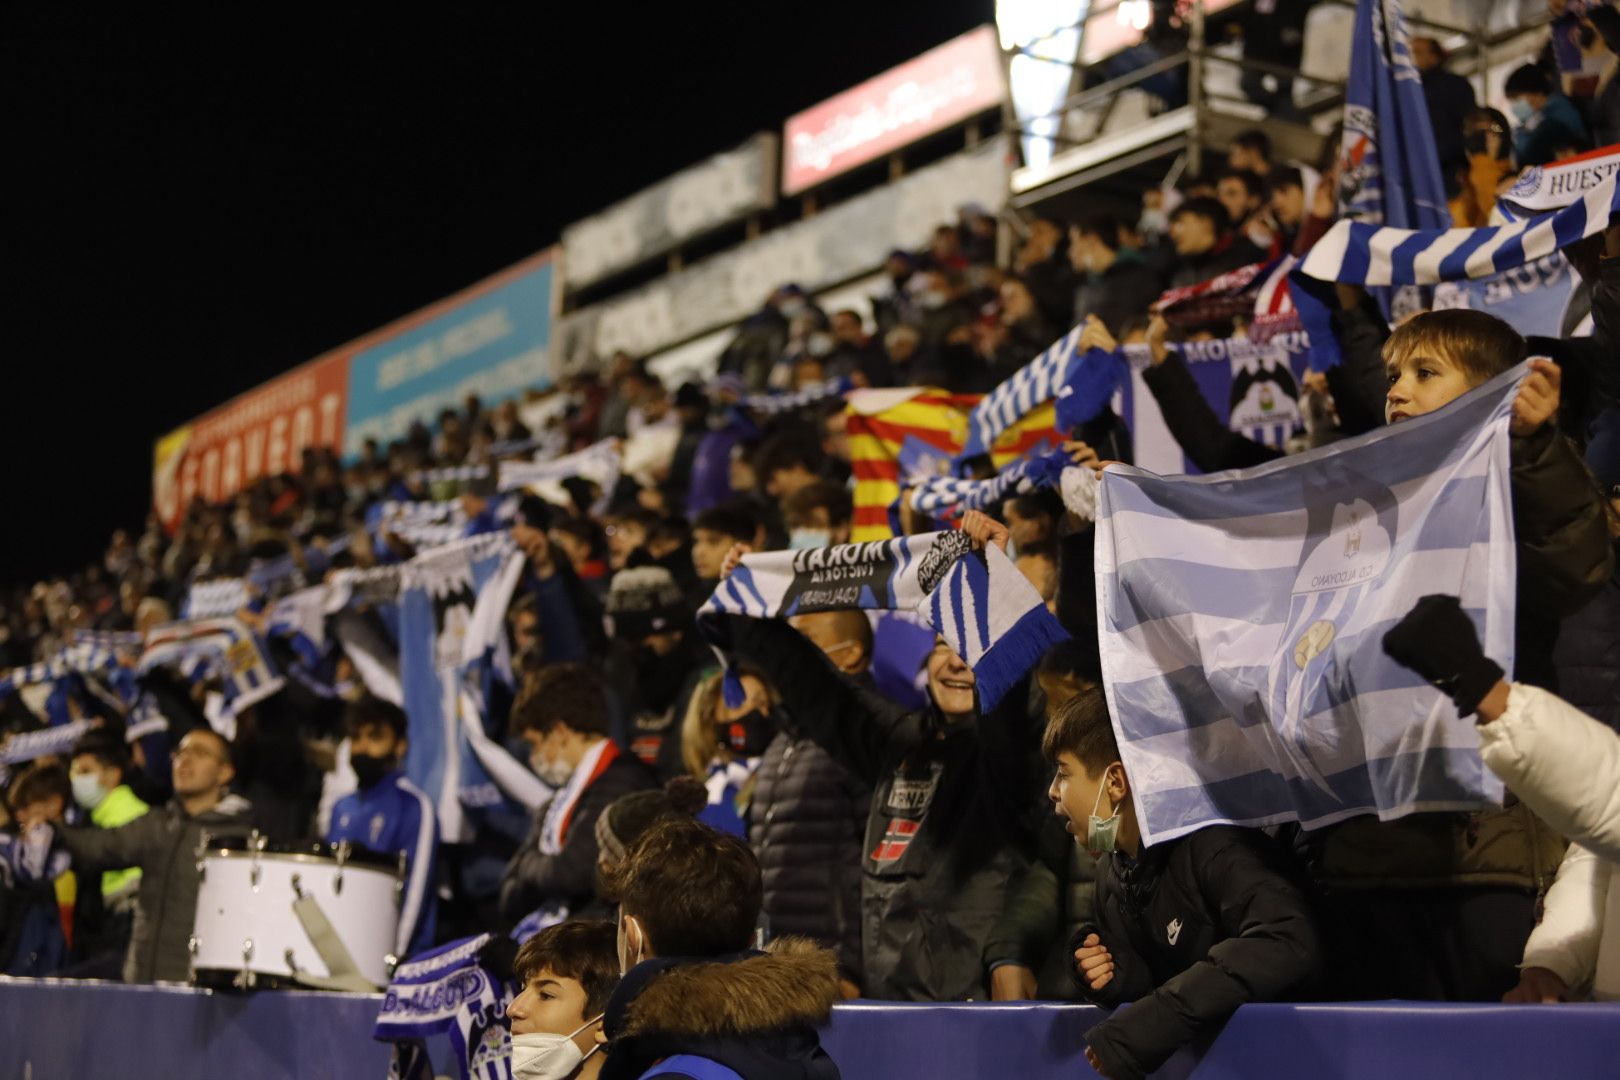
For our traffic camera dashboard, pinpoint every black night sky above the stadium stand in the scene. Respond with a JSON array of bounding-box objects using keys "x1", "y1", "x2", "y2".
[{"x1": 0, "y1": 0, "x2": 993, "y2": 583}]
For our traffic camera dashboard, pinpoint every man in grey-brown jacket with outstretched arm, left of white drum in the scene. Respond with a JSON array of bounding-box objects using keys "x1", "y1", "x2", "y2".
[{"x1": 58, "y1": 727, "x2": 254, "y2": 983}]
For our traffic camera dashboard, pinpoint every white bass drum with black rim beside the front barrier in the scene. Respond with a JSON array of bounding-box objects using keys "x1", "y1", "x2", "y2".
[{"x1": 191, "y1": 832, "x2": 403, "y2": 989}]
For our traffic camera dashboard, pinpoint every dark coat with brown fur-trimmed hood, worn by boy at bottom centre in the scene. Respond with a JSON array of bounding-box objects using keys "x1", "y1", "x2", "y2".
[{"x1": 601, "y1": 938, "x2": 839, "y2": 1080}]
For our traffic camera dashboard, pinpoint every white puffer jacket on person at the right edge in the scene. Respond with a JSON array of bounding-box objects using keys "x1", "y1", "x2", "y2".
[{"x1": 1479, "y1": 683, "x2": 1620, "y2": 1001}]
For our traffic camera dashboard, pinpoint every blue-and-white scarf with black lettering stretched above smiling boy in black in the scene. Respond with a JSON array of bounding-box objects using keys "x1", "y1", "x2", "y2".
[{"x1": 698, "y1": 533, "x2": 1068, "y2": 709}]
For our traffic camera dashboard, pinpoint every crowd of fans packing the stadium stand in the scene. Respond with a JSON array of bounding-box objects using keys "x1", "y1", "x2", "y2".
[{"x1": 0, "y1": 6, "x2": 1620, "y2": 1077}]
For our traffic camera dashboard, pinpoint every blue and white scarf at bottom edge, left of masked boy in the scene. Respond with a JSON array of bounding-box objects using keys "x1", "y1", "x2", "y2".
[{"x1": 371, "y1": 934, "x2": 515, "y2": 1080}]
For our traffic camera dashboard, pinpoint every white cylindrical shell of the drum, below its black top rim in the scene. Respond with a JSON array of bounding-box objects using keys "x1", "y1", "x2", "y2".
[{"x1": 191, "y1": 850, "x2": 400, "y2": 986}]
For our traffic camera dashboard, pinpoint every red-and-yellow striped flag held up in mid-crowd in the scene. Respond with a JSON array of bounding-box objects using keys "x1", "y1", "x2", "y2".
[{"x1": 846, "y1": 387, "x2": 1061, "y2": 542}]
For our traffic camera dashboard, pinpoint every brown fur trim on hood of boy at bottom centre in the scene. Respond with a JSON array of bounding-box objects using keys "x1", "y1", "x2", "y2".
[{"x1": 620, "y1": 938, "x2": 839, "y2": 1040}]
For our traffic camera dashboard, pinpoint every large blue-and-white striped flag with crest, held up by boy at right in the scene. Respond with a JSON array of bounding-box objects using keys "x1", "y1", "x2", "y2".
[{"x1": 1095, "y1": 364, "x2": 1526, "y2": 844}]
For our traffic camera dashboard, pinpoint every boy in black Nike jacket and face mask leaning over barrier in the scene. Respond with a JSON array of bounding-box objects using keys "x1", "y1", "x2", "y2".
[{"x1": 1042, "y1": 688, "x2": 1320, "y2": 1080}]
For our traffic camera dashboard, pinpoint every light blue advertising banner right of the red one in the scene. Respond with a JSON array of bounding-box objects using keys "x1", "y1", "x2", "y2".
[{"x1": 343, "y1": 251, "x2": 554, "y2": 457}]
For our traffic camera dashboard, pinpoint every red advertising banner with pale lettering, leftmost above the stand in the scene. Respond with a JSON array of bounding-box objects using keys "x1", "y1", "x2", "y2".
[{"x1": 152, "y1": 345, "x2": 353, "y2": 531}]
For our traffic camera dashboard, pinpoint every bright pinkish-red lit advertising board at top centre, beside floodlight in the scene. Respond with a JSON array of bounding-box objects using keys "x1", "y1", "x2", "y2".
[{"x1": 782, "y1": 26, "x2": 1006, "y2": 194}]
